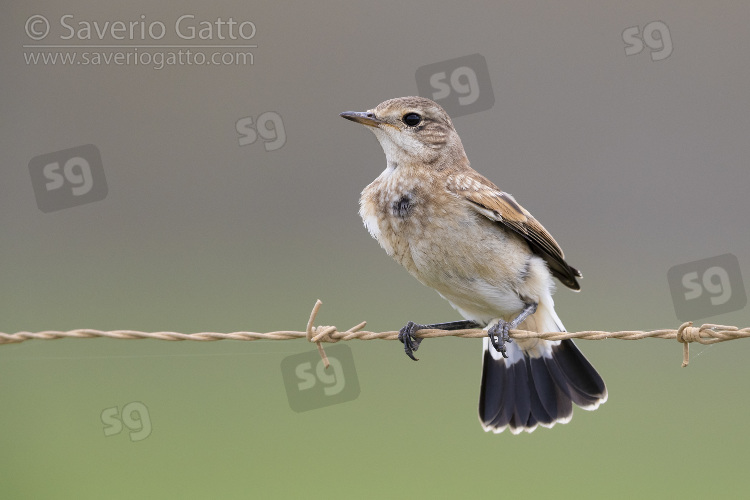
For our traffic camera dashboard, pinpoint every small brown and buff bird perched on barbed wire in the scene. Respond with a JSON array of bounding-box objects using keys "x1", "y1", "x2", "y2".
[{"x1": 340, "y1": 96, "x2": 607, "y2": 434}]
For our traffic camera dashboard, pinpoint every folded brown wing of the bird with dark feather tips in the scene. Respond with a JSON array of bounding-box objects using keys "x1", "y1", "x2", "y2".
[{"x1": 447, "y1": 172, "x2": 582, "y2": 290}]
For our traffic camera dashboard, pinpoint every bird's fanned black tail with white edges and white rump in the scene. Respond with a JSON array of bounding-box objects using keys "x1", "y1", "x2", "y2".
[{"x1": 479, "y1": 308, "x2": 607, "y2": 434}]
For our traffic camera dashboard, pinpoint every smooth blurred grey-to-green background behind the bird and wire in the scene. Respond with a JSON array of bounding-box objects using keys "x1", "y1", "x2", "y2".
[{"x1": 0, "y1": 0, "x2": 750, "y2": 499}]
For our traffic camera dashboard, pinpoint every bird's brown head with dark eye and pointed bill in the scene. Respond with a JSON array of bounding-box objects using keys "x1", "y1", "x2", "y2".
[{"x1": 341, "y1": 97, "x2": 466, "y2": 168}]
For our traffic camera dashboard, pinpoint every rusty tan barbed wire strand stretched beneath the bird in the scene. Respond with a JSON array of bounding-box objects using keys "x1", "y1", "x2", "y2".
[{"x1": 0, "y1": 300, "x2": 750, "y2": 368}]
